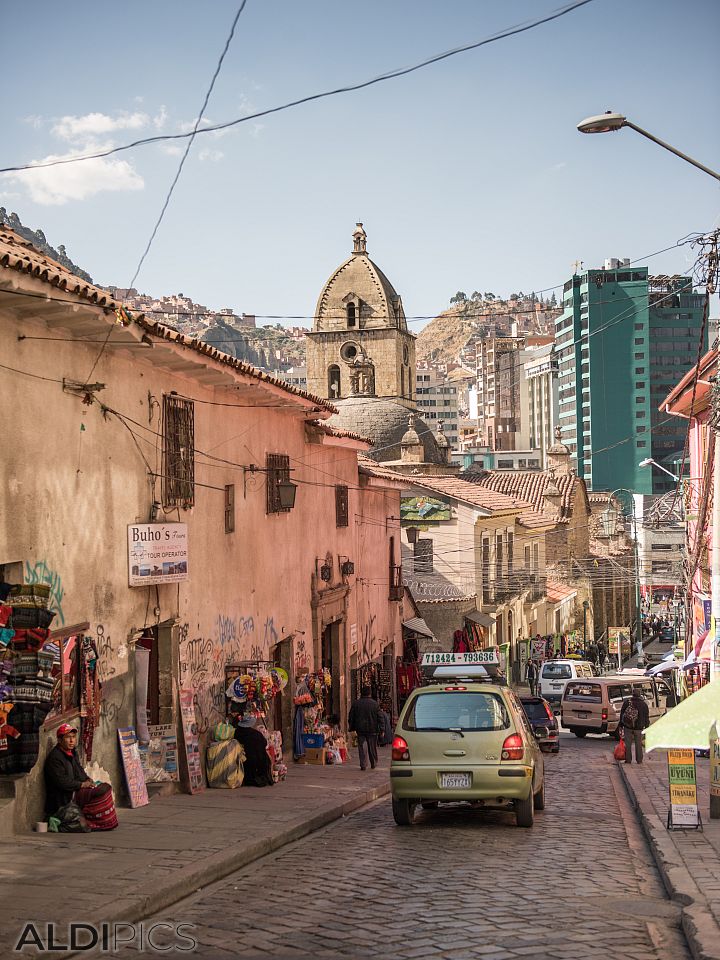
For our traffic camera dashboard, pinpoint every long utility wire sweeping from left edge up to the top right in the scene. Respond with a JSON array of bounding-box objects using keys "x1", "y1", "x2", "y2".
[{"x1": 0, "y1": 0, "x2": 591, "y2": 173}]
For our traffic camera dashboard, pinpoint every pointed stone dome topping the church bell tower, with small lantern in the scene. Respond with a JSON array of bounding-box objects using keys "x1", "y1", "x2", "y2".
[{"x1": 313, "y1": 223, "x2": 407, "y2": 333}]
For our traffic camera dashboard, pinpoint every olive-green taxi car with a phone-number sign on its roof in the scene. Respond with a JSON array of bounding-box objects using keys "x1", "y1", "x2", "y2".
[{"x1": 390, "y1": 654, "x2": 545, "y2": 827}]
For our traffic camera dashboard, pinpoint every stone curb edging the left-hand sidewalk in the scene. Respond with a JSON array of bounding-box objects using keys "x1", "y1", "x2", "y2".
[{"x1": 63, "y1": 780, "x2": 390, "y2": 960}]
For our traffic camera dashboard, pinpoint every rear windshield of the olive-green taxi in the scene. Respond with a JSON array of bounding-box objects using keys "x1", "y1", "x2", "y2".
[{"x1": 403, "y1": 691, "x2": 510, "y2": 730}]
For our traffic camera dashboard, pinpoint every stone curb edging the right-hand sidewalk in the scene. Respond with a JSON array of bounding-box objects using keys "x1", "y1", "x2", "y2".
[{"x1": 618, "y1": 763, "x2": 720, "y2": 960}]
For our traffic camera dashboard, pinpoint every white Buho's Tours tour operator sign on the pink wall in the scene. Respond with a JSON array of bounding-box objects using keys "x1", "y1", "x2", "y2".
[{"x1": 128, "y1": 523, "x2": 188, "y2": 587}]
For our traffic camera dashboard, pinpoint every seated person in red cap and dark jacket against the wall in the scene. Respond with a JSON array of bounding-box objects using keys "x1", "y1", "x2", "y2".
[{"x1": 44, "y1": 723, "x2": 118, "y2": 830}]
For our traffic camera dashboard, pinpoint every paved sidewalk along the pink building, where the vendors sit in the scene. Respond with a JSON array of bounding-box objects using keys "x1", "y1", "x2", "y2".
[{"x1": 0, "y1": 748, "x2": 390, "y2": 956}]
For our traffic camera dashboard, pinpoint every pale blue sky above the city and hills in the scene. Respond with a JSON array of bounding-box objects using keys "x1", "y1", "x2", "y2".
[{"x1": 0, "y1": 0, "x2": 720, "y2": 332}]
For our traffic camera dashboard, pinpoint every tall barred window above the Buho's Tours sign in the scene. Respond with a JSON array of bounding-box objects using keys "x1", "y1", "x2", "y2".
[{"x1": 162, "y1": 394, "x2": 195, "y2": 510}]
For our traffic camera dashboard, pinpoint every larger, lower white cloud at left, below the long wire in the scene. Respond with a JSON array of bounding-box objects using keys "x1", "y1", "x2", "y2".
[{"x1": 4, "y1": 152, "x2": 145, "y2": 206}]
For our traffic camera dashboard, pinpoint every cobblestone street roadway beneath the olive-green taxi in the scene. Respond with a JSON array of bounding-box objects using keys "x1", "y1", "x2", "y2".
[{"x1": 123, "y1": 736, "x2": 690, "y2": 960}]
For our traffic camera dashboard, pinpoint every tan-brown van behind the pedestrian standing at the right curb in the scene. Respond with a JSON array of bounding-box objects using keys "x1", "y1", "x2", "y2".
[{"x1": 561, "y1": 674, "x2": 674, "y2": 738}]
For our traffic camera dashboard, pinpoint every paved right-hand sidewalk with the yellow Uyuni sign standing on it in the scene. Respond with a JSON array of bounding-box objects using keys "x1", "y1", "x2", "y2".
[{"x1": 618, "y1": 750, "x2": 720, "y2": 960}]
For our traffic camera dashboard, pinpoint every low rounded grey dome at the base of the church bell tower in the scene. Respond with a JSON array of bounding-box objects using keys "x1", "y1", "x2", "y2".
[{"x1": 326, "y1": 397, "x2": 445, "y2": 464}]
